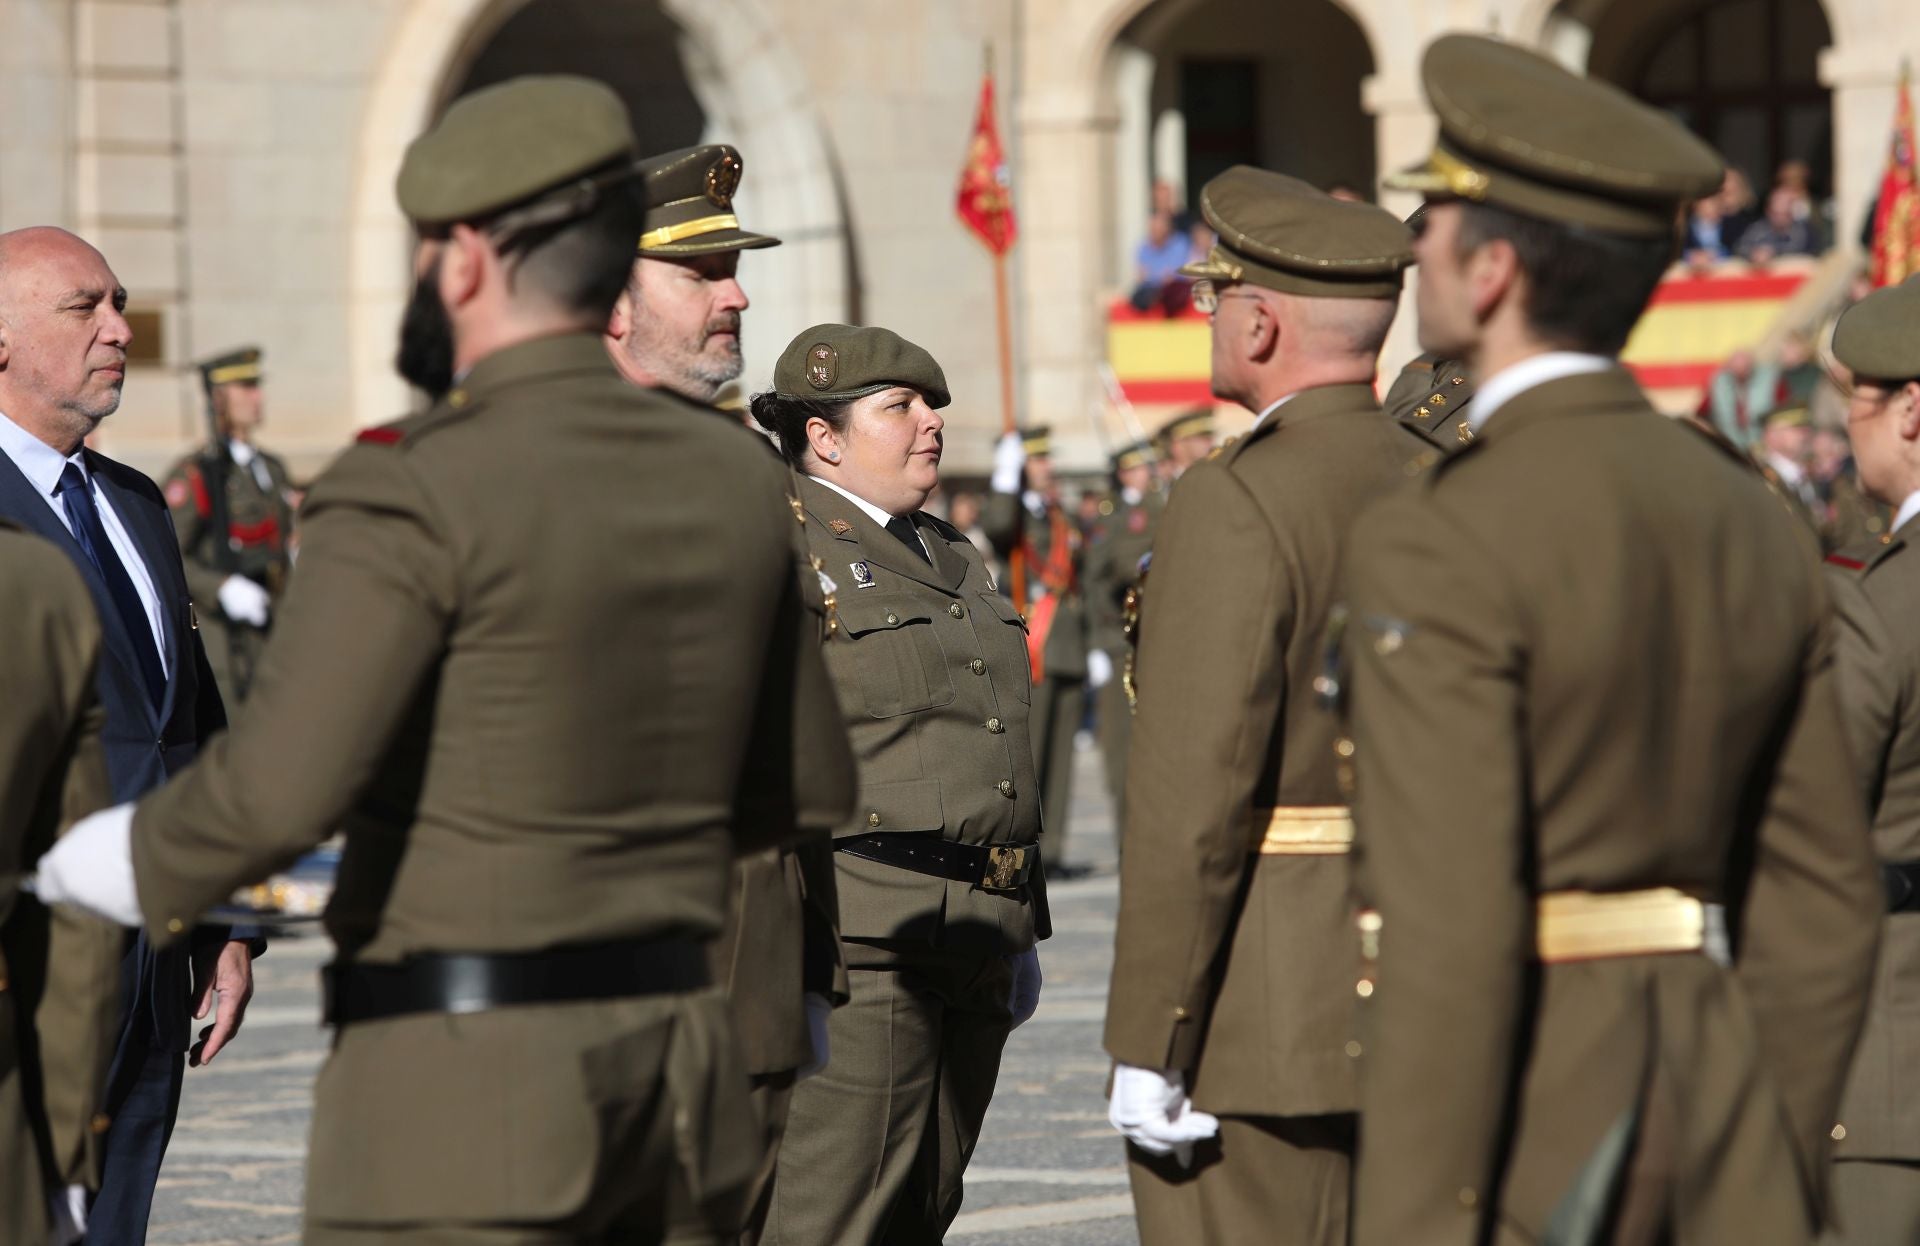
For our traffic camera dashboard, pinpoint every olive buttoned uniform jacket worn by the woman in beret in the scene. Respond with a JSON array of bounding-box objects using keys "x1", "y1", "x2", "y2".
[{"x1": 801, "y1": 478, "x2": 1052, "y2": 952}]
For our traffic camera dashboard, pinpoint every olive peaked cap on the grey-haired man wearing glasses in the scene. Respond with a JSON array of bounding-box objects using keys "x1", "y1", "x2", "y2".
[{"x1": 1181, "y1": 165, "x2": 1413, "y2": 298}]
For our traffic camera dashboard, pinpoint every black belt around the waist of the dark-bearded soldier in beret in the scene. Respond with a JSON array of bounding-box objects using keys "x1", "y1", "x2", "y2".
[{"x1": 321, "y1": 939, "x2": 712, "y2": 1025}]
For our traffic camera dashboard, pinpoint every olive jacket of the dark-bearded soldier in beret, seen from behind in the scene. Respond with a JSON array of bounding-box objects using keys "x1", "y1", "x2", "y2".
[{"x1": 132, "y1": 334, "x2": 852, "y2": 1221}]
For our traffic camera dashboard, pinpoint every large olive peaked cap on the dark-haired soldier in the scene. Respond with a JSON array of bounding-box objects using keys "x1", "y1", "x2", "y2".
[{"x1": 1386, "y1": 35, "x2": 1724, "y2": 238}]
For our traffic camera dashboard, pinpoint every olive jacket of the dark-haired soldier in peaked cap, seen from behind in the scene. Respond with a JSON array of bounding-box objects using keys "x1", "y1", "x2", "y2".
[{"x1": 1348, "y1": 369, "x2": 1882, "y2": 1246}]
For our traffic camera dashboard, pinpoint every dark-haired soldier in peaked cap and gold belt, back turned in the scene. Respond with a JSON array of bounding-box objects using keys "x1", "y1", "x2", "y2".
[{"x1": 1344, "y1": 35, "x2": 1884, "y2": 1246}]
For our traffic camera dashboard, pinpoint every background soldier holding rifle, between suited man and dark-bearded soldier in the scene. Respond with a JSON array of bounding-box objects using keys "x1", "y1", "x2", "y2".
[{"x1": 165, "y1": 346, "x2": 294, "y2": 705}]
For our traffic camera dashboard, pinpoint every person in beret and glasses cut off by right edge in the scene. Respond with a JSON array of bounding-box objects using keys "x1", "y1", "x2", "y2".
[{"x1": 1826, "y1": 278, "x2": 1920, "y2": 1246}]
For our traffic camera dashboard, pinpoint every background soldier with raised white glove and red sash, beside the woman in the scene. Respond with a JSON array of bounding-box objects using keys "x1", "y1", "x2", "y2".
[{"x1": 979, "y1": 428, "x2": 1089, "y2": 877}]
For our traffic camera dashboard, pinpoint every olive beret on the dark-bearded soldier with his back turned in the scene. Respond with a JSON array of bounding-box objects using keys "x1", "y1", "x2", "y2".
[{"x1": 397, "y1": 75, "x2": 634, "y2": 228}]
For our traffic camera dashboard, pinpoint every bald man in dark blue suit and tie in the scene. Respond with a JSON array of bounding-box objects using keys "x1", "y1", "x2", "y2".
[{"x1": 0, "y1": 228, "x2": 261, "y2": 1246}]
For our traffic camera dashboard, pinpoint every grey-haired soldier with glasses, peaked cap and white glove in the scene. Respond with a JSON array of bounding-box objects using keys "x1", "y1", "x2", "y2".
[{"x1": 1106, "y1": 165, "x2": 1430, "y2": 1246}]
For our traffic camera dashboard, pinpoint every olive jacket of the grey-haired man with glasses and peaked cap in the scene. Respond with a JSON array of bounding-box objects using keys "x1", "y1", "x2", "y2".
[{"x1": 1106, "y1": 386, "x2": 1432, "y2": 1115}]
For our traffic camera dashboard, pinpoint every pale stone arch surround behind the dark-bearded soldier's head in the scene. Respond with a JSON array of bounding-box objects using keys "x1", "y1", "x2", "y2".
[{"x1": 348, "y1": 0, "x2": 851, "y2": 424}]
